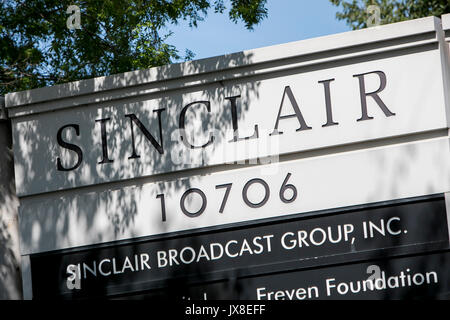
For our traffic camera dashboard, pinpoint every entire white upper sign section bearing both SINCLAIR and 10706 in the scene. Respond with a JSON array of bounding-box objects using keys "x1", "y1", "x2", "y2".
[{"x1": 5, "y1": 17, "x2": 450, "y2": 255}]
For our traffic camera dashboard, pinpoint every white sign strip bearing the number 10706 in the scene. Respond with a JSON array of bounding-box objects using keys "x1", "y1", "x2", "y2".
[{"x1": 19, "y1": 137, "x2": 450, "y2": 254}]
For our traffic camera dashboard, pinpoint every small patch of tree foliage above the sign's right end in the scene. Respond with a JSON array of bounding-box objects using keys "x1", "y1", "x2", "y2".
[{"x1": 330, "y1": 0, "x2": 450, "y2": 29}]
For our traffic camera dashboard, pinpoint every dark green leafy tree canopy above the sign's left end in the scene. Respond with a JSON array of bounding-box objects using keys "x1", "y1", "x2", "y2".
[{"x1": 0, "y1": 0, "x2": 267, "y2": 95}]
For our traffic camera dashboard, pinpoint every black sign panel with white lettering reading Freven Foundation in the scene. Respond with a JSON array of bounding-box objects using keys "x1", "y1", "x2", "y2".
[{"x1": 127, "y1": 251, "x2": 450, "y2": 300}]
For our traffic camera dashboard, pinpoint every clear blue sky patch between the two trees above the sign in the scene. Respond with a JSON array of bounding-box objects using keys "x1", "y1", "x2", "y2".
[{"x1": 168, "y1": 0, "x2": 350, "y2": 59}]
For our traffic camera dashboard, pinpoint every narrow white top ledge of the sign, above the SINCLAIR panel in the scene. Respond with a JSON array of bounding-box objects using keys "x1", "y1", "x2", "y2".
[{"x1": 5, "y1": 14, "x2": 440, "y2": 109}]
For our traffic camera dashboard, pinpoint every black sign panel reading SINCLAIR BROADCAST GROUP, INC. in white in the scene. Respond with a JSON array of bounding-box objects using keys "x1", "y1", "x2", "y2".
[{"x1": 31, "y1": 196, "x2": 449, "y2": 298}]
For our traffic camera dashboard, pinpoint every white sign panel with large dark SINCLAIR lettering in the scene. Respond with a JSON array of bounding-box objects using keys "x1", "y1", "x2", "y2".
[{"x1": 9, "y1": 50, "x2": 448, "y2": 196}]
